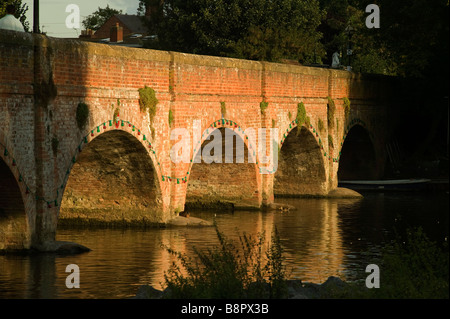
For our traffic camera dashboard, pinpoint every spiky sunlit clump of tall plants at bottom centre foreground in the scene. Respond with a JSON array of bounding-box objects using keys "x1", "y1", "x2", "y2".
[{"x1": 164, "y1": 226, "x2": 287, "y2": 299}]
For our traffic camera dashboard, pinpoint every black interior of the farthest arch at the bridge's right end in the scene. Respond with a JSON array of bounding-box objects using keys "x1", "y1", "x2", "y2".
[{"x1": 338, "y1": 125, "x2": 377, "y2": 181}]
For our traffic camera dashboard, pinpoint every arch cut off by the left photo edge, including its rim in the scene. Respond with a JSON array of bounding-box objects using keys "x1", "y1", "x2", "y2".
[{"x1": 0, "y1": 146, "x2": 31, "y2": 250}]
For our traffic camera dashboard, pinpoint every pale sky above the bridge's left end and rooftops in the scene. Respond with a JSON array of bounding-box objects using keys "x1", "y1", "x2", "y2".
[{"x1": 22, "y1": 0, "x2": 139, "y2": 38}]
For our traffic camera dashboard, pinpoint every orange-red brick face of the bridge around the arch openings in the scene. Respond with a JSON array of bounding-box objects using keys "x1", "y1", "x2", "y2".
[{"x1": 0, "y1": 31, "x2": 394, "y2": 249}]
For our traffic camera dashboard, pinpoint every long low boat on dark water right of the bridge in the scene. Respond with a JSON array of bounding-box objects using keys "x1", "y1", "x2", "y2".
[{"x1": 339, "y1": 178, "x2": 431, "y2": 190}]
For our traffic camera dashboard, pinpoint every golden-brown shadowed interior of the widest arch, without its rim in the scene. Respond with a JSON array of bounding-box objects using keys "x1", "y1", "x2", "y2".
[{"x1": 60, "y1": 130, "x2": 159, "y2": 217}]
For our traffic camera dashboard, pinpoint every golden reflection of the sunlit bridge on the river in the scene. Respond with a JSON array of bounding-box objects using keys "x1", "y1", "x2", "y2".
[{"x1": 0, "y1": 195, "x2": 380, "y2": 298}]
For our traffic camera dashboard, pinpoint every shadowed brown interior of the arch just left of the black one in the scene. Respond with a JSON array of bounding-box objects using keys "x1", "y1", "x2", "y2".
[{"x1": 273, "y1": 127, "x2": 326, "y2": 197}]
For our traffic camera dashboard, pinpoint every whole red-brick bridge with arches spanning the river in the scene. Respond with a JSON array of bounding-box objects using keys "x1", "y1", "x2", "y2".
[{"x1": 0, "y1": 31, "x2": 400, "y2": 249}]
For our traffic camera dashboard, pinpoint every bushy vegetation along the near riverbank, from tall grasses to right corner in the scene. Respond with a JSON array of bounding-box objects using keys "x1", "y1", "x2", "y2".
[{"x1": 160, "y1": 227, "x2": 449, "y2": 299}]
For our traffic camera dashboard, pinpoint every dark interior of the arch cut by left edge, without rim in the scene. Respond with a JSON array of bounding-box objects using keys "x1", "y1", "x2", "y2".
[{"x1": 0, "y1": 159, "x2": 27, "y2": 249}]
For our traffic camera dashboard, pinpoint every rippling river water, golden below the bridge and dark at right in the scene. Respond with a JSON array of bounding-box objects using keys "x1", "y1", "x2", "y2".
[{"x1": 0, "y1": 192, "x2": 449, "y2": 299}]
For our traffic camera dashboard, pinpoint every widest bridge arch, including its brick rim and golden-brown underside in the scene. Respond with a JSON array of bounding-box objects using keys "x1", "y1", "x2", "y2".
[{"x1": 59, "y1": 126, "x2": 166, "y2": 225}]
